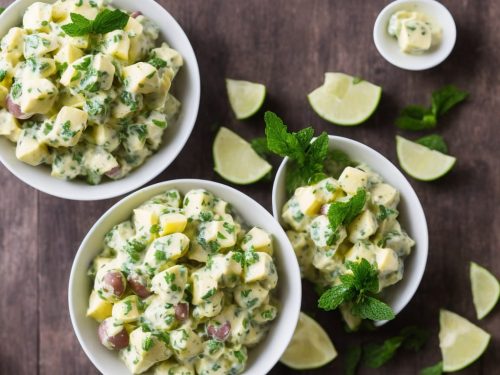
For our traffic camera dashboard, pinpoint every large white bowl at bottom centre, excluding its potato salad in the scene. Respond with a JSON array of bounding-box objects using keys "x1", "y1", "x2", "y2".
[{"x1": 68, "y1": 179, "x2": 302, "y2": 375}]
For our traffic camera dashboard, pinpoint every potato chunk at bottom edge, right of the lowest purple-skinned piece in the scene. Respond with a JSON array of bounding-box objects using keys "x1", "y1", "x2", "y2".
[{"x1": 120, "y1": 328, "x2": 172, "y2": 374}]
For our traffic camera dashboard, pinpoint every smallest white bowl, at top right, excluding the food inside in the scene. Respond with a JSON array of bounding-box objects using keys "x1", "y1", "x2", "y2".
[{"x1": 373, "y1": 0, "x2": 457, "y2": 70}]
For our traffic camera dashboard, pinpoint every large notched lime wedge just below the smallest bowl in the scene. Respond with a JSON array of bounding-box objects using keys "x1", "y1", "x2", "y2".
[{"x1": 307, "y1": 73, "x2": 382, "y2": 126}]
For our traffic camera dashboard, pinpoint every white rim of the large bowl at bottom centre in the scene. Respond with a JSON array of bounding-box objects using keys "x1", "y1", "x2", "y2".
[{"x1": 68, "y1": 179, "x2": 302, "y2": 375}]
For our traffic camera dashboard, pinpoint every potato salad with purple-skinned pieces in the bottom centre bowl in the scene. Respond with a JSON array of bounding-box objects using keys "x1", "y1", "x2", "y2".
[{"x1": 87, "y1": 189, "x2": 278, "y2": 375}]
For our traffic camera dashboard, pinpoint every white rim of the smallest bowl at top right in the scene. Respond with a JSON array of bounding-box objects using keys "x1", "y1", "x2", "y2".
[{"x1": 373, "y1": 0, "x2": 457, "y2": 71}]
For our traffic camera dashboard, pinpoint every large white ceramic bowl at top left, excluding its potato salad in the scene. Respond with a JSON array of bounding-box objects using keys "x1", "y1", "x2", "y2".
[{"x1": 0, "y1": 0, "x2": 200, "y2": 200}]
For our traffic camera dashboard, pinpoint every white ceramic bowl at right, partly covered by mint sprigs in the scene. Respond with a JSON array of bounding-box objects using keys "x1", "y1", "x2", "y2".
[{"x1": 272, "y1": 135, "x2": 429, "y2": 325}]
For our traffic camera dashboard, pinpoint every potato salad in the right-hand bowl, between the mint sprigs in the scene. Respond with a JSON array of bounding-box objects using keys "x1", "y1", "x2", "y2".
[{"x1": 282, "y1": 165, "x2": 415, "y2": 329}]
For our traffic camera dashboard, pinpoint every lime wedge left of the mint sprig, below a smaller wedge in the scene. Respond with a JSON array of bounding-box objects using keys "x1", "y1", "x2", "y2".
[{"x1": 212, "y1": 127, "x2": 272, "y2": 185}]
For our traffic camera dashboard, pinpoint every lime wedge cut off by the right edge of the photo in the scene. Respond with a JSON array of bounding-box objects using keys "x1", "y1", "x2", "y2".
[{"x1": 470, "y1": 262, "x2": 500, "y2": 319}]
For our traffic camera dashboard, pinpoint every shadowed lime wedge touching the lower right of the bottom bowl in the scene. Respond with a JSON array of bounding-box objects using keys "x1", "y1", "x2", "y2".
[{"x1": 280, "y1": 312, "x2": 337, "y2": 370}]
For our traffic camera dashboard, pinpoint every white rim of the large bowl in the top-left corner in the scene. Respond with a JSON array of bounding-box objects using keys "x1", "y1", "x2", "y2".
[{"x1": 0, "y1": 0, "x2": 201, "y2": 201}]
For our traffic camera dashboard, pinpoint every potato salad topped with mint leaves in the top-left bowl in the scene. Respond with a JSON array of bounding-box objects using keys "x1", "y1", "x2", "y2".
[{"x1": 0, "y1": 0, "x2": 183, "y2": 184}]
